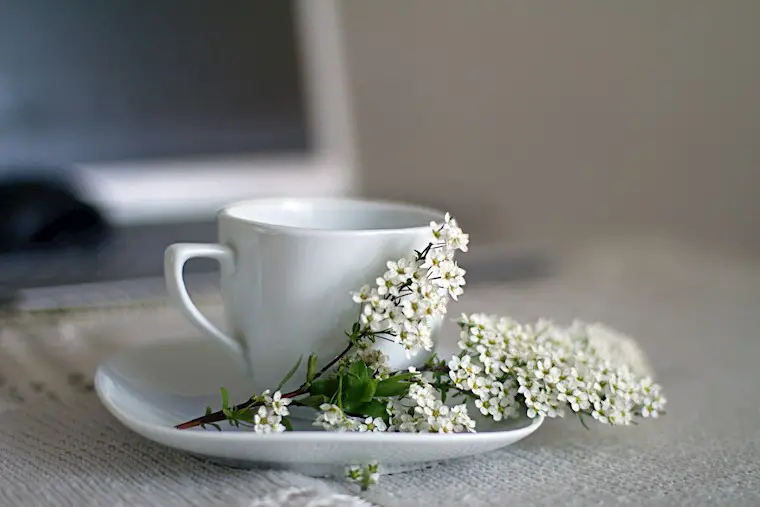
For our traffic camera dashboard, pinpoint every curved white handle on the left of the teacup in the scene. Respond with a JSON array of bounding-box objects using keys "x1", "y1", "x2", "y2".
[{"x1": 164, "y1": 243, "x2": 248, "y2": 371}]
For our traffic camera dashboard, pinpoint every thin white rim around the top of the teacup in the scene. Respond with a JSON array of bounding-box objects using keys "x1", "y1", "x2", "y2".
[{"x1": 217, "y1": 197, "x2": 444, "y2": 235}]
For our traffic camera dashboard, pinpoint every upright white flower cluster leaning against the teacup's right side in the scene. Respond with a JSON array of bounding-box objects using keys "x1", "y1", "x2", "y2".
[{"x1": 352, "y1": 213, "x2": 469, "y2": 356}]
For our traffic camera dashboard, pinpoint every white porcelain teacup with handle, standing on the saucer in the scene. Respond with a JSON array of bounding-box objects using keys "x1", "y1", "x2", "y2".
[{"x1": 164, "y1": 198, "x2": 443, "y2": 393}]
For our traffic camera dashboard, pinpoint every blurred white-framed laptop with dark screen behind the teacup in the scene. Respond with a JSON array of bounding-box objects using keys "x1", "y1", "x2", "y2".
[{"x1": 0, "y1": 0, "x2": 355, "y2": 301}]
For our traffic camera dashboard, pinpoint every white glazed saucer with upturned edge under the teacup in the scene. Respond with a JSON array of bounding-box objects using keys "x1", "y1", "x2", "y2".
[{"x1": 95, "y1": 340, "x2": 543, "y2": 475}]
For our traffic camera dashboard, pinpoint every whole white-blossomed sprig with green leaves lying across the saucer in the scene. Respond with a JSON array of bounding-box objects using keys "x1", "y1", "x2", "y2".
[{"x1": 183, "y1": 213, "x2": 666, "y2": 496}]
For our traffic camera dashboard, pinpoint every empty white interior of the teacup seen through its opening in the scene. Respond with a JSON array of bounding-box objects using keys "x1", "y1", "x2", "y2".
[{"x1": 221, "y1": 199, "x2": 443, "y2": 231}]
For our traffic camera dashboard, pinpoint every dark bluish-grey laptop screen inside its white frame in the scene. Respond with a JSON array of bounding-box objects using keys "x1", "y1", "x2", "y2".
[{"x1": 0, "y1": 0, "x2": 308, "y2": 165}]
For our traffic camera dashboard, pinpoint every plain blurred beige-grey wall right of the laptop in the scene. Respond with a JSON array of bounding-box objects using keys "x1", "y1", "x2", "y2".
[{"x1": 341, "y1": 0, "x2": 760, "y2": 253}]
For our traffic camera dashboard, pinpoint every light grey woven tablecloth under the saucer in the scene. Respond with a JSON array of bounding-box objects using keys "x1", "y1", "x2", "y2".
[{"x1": 0, "y1": 241, "x2": 760, "y2": 507}]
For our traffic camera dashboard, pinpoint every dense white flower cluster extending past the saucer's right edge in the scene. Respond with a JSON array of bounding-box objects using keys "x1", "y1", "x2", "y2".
[{"x1": 448, "y1": 314, "x2": 665, "y2": 425}]
